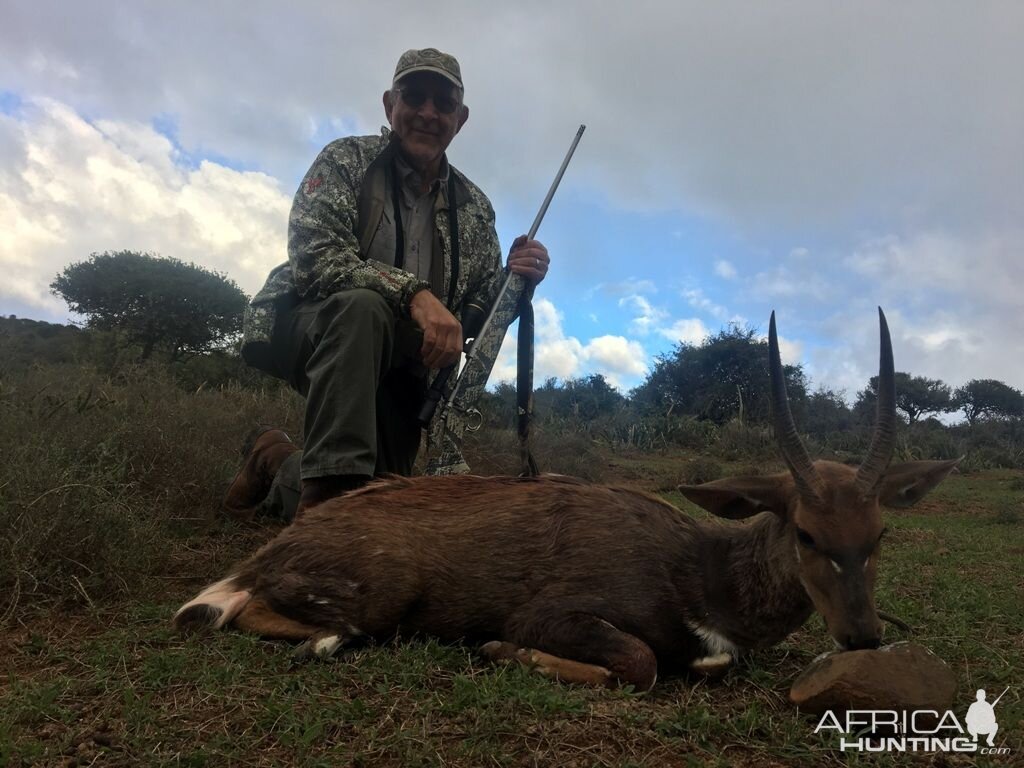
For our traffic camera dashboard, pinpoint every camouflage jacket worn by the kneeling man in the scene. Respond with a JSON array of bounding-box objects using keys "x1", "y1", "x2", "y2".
[{"x1": 242, "y1": 128, "x2": 504, "y2": 370}]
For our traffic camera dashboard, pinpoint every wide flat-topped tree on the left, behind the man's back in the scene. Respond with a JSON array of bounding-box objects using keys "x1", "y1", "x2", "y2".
[{"x1": 50, "y1": 251, "x2": 248, "y2": 359}]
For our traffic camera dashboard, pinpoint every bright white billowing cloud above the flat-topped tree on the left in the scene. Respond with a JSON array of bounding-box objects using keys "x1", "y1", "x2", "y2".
[{"x1": 0, "y1": 99, "x2": 291, "y2": 316}]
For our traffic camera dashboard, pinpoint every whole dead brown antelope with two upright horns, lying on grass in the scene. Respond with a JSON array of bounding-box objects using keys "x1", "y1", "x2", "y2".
[{"x1": 174, "y1": 310, "x2": 956, "y2": 690}]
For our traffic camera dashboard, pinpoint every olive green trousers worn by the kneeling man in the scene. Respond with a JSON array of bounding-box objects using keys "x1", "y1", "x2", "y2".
[{"x1": 263, "y1": 288, "x2": 428, "y2": 519}]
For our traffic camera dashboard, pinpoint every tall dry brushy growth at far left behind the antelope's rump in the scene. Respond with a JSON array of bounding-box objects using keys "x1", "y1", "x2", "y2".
[{"x1": 0, "y1": 366, "x2": 301, "y2": 617}]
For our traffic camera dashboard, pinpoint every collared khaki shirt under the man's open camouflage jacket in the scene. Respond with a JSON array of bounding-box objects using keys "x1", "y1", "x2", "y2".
[{"x1": 367, "y1": 153, "x2": 450, "y2": 284}]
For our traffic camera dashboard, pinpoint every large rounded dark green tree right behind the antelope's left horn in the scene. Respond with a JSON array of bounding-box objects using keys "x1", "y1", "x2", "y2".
[{"x1": 633, "y1": 326, "x2": 807, "y2": 424}]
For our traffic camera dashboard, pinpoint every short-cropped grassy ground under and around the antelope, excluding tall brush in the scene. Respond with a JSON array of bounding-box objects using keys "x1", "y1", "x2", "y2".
[{"x1": 0, "y1": 454, "x2": 1024, "y2": 766}]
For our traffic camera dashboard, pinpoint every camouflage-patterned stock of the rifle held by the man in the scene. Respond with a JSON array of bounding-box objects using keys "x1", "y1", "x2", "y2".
[{"x1": 425, "y1": 272, "x2": 534, "y2": 475}]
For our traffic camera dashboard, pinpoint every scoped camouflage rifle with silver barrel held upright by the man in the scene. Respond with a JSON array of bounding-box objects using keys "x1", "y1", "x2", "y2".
[{"x1": 419, "y1": 125, "x2": 586, "y2": 475}]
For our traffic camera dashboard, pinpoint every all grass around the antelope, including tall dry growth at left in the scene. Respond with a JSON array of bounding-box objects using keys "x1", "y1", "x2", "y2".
[{"x1": 0, "y1": 369, "x2": 1024, "y2": 768}]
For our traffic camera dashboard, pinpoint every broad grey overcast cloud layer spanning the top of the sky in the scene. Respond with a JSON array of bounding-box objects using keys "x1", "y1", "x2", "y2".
[{"x1": 0, "y1": 0, "x2": 1024, "y2": 232}]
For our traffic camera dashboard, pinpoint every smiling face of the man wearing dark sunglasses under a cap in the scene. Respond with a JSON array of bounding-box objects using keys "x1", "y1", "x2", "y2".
[{"x1": 384, "y1": 72, "x2": 469, "y2": 170}]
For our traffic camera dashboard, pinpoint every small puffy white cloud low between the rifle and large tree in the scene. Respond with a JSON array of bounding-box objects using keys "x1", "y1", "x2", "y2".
[{"x1": 490, "y1": 299, "x2": 648, "y2": 389}]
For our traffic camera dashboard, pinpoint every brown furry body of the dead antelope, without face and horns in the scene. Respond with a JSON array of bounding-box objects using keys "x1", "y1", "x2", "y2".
[{"x1": 176, "y1": 463, "x2": 958, "y2": 690}]
